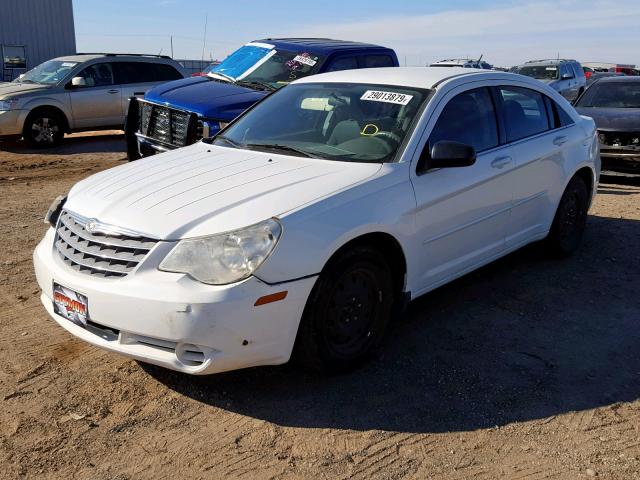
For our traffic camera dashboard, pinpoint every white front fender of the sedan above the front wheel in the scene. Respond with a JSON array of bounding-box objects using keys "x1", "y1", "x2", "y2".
[{"x1": 256, "y1": 163, "x2": 415, "y2": 283}]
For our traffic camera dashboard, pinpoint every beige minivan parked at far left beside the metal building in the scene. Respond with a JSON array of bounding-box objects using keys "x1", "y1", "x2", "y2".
[{"x1": 0, "y1": 53, "x2": 185, "y2": 148}]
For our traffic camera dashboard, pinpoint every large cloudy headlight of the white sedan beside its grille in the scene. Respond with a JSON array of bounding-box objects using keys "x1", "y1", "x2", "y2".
[{"x1": 159, "y1": 218, "x2": 282, "y2": 285}]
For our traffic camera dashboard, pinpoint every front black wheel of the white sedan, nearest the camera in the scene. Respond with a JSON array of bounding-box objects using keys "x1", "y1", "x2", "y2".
[{"x1": 294, "y1": 247, "x2": 394, "y2": 373}]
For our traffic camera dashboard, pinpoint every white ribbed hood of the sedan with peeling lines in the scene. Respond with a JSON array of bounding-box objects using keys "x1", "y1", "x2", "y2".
[{"x1": 65, "y1": 142, "x2": 381, "y2": 240}]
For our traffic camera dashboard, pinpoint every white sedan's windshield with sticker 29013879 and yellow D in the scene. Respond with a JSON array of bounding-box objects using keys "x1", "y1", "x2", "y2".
[{"x1": 213, "y1": 83, "x2": 429, "y2": 163}]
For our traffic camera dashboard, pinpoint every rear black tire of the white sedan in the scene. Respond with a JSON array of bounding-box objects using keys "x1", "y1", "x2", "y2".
[{"x1": 546, "y1": 177, "x2": 589, "y2": 257}]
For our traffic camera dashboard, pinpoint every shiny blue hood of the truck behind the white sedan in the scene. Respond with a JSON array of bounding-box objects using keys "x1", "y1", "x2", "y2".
[{"x1": 144, "y1": 76, "x2": 267, "y2": 120}]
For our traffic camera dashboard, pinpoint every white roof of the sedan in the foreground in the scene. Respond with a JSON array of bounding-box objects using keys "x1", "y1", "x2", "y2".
[{"x1": 293, "y1": 67, "x2": 524, "y2": 88}]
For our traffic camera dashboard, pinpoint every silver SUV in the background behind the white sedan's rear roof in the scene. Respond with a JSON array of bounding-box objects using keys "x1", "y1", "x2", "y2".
[{"x1": 516, "y1": 59, "x2": 587, "y2": 102}]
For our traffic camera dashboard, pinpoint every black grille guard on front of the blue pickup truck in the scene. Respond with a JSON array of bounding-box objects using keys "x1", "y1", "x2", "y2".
[{"x1": 140, "y1": 102, "x2": 195, "y2": 147}]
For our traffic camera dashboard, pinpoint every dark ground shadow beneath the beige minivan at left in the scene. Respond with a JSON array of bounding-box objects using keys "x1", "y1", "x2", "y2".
[{"x1": 0, "y1": 130, "x2": 126, "y2": 155}]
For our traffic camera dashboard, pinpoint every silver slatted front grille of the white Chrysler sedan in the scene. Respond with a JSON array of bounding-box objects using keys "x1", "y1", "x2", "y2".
[{"x1": 55, "y1": 211, "x2": 157, "y2": 278}]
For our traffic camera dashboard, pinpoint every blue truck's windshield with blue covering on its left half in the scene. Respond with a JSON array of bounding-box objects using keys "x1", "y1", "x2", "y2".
[{"x1": 210, "y1": 43, "x2": 324, "y2": 88}]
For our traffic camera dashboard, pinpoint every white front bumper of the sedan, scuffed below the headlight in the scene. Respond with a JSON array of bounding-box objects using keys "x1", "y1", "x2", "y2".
[{"x1": 33, "y1": 228, "x2": 315, "y2": 374}]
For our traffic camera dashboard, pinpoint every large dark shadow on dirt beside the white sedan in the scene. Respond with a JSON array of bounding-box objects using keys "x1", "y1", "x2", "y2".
[{"x1": 143, "y1": 216, "x2": 640, "y2": 432}]
